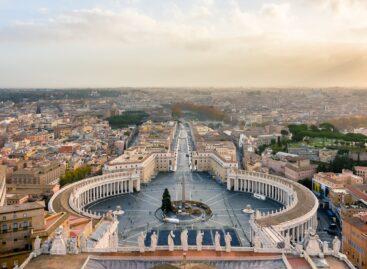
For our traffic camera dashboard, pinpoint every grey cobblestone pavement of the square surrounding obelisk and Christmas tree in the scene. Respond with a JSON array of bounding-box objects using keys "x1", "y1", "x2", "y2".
[{"x1": 88, "y1": 124, "x2": 281, "y2": 246}]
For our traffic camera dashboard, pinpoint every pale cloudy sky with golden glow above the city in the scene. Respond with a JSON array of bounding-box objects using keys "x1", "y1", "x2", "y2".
[{"x1": 0, "y1": 0, "x2": 367, "y2": 88}]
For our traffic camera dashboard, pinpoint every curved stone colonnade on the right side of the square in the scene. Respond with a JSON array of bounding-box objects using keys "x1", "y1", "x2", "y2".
[{"x1": 227, "y1": 170, "x2": 318, "y2": 242}]
